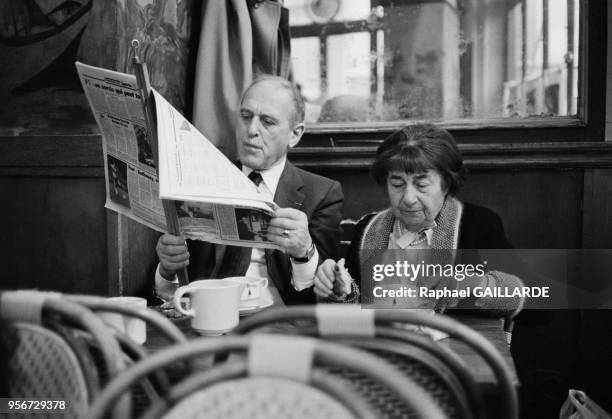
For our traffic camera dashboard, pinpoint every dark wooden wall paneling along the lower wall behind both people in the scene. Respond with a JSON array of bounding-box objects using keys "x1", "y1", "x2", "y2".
[{"x1": 0, "y1": 140, "x2": 612, "y2": 296}]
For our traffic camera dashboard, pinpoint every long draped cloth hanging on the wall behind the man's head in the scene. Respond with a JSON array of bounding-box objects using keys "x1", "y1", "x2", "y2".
[{"x1": 193, "y1": 0, "x2": 290, "y2": 160}]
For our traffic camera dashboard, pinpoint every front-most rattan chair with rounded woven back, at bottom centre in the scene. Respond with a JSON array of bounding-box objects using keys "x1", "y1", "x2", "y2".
[{"x1": 88, "y1": 334, "x2": 444, "y2": 419}]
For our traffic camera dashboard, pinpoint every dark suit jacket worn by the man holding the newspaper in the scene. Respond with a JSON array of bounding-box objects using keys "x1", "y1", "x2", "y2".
[{"x1": 187, "y1": 161, "x2": 344, "y2": 305}]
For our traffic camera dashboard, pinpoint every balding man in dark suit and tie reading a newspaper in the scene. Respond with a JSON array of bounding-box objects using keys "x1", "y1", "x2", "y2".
[{"x1": 155, "y1": 76, "x2": 343, "y2": 304}]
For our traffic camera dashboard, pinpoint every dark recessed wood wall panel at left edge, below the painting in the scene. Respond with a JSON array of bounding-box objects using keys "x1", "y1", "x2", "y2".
[{"x1": 0, "y1": 177, "x2": 107, "y2": 295}]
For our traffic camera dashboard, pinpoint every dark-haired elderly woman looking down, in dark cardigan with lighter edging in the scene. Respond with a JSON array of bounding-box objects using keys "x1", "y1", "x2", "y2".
[{"x1": 314, "y1": 125, "x2": 523, "y2": 317}]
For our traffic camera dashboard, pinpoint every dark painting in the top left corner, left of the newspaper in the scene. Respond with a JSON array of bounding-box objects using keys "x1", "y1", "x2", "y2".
[{"x1": 0, "y1": 0, "x2": 94, "y2": 135}]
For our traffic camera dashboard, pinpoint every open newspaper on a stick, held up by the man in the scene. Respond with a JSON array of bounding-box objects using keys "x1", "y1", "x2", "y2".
[{"x1": 76, "y1": 62, "x2": 276, "y2": 248}]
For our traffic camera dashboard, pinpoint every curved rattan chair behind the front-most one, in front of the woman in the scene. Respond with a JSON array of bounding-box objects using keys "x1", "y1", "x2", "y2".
[{"x1": 234, "y1": 304, "x2": 518, "y2": 419}]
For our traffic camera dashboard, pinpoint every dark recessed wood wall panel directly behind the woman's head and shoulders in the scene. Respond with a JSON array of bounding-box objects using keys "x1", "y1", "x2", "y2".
[{"x1": 318, "y1": 169, "x2": 583, "y2": 249}]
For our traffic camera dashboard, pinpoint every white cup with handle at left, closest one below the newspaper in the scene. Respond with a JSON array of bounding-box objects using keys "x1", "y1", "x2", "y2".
[{"x1": 173, "y1": 279, "x2": 245, "y2": 336}]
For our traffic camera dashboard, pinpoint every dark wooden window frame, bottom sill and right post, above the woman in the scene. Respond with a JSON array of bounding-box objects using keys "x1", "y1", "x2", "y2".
[{"x1": 292, "y1": 0, "x2": 608, "y2": 148}]
